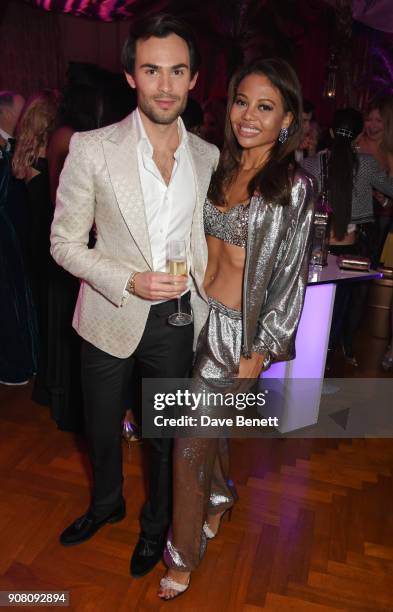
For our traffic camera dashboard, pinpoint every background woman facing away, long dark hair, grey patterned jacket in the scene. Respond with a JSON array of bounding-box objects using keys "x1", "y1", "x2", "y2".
[{"x1": 302, "y1": 108, "x2": 393, "y2": 366}]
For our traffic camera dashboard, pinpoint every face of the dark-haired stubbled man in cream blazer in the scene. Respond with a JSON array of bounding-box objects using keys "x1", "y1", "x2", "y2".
[{"x1": 126, "y1": 34, "x2": 198, "y2": 125}]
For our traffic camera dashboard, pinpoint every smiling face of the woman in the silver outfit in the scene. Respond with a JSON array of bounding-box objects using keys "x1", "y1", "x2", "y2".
[{"x1": 230, "y1": 74, "x2": 292, "y2": 150}]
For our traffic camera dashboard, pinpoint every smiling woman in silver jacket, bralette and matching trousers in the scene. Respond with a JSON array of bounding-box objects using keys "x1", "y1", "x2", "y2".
[{"x1": 158, "y1": 59, "x2": 315, "y2": 599}]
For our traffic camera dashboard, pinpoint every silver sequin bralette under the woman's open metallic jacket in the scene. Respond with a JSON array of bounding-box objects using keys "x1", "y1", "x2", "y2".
[{"x1": 203, "y1": 198, "x2": 250, "y2": 249}]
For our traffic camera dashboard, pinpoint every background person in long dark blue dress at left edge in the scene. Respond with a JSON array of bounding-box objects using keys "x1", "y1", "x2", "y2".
[{"x1": 0, "y1": 91, "x2": 38, "y2": 385}]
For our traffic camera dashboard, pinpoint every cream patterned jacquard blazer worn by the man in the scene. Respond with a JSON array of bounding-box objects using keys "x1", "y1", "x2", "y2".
[{"x1": 51, "y1": 115, "x2": 219, "y2": 358}]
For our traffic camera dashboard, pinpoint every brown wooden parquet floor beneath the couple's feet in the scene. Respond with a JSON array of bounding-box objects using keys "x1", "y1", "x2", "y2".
[{"x1": 0, "y1": 338, "x2": 393, "y2": 612}]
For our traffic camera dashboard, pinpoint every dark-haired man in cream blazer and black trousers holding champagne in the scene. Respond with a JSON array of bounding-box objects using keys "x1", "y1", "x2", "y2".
[{"x1": 51, "y1": 15, "x2": 218, "y2": 576}]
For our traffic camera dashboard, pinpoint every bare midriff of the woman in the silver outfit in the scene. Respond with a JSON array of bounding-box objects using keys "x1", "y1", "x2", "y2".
[{"x1": 204, "y1": 236, "x2": 246, "y2": 310}]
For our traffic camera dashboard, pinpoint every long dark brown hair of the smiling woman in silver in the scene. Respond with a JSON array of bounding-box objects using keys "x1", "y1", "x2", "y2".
[{"x1": 208, "y1": 58, "x2": 302, "y2": 206}]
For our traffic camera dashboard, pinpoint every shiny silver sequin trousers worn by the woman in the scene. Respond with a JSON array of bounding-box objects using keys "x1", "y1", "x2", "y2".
[{"x1": 164, "y1": 298, "x2": 242, "y2": 572}]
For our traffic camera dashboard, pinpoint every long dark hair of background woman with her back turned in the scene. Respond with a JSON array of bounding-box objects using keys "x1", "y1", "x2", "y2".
[{"x1": 327, "y1": 108, "x2": 363, "y2": 240}]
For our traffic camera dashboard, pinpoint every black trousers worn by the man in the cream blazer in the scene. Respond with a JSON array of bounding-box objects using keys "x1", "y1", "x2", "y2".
[{"x1": 82, "y1": 294, "x2": 194, "y2": 537}]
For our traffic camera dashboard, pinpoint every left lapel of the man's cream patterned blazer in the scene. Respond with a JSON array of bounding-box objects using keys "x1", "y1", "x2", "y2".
[{"x1": 103, "y1": 114, "x2": 153, "y2": 269}]
